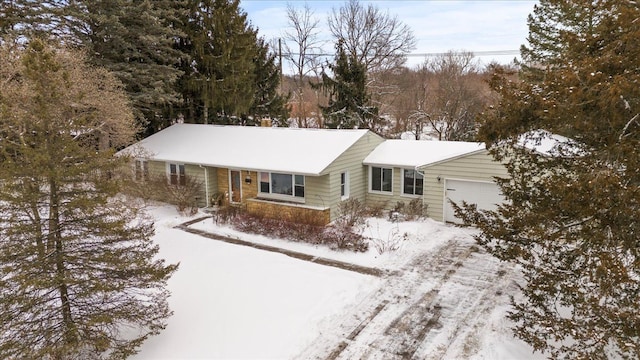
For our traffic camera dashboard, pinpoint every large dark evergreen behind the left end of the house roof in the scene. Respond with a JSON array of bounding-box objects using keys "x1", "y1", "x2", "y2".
[{"x1": 73, "y1": 0, "x2": 184, "y2": 135}]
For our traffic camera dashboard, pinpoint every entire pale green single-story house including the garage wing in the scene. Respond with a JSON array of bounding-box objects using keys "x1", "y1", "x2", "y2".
[{"x1": 122, "y1": 124, "x2": 507, "y2": 223}]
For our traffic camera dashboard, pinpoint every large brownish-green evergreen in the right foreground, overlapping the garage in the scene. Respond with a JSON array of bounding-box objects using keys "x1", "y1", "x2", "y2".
[{"x1": 460, "y1": 0, "x2": 640, "y2": 359}]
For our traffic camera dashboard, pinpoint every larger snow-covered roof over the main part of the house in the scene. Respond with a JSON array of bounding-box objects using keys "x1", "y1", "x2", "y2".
[{"x1": 121, "y1": 124, "x2": 368, "y2": 175}]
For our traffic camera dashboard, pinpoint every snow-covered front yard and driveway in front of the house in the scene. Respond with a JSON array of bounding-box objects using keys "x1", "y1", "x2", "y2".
[{"x1": 134, "y1": 206, "x2": 543, "y2": 359}]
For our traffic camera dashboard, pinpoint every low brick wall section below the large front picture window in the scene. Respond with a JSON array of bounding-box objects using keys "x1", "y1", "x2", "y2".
[{"x1": 246, "y1": 200, "x2": 331, "y2": 225}]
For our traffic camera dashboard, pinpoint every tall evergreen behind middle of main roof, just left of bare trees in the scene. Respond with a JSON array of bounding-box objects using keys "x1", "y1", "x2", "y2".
[{"x1": 180, "y1": 0, "x2": 257, "y2": 124}]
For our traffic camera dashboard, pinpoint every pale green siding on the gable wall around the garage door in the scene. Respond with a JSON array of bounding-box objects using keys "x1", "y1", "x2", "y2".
[{"x1": 420, "y1": 151, "x2": 508, "y2": 221}]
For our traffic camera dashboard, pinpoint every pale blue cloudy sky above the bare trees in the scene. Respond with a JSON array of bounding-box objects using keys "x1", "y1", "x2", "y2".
[{"x1": 240, "y1": 0, "x2": 537, "y2": 72}]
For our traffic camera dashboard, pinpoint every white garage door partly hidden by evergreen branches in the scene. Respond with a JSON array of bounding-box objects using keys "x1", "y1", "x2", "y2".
[{"x1": 444, "y1": 179, "x2": 504, "y2": 224}]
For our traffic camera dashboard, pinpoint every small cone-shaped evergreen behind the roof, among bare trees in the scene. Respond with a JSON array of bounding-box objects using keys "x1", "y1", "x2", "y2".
[{"x1": 316, "y1": 41, "x2": 379, "y2": 130}]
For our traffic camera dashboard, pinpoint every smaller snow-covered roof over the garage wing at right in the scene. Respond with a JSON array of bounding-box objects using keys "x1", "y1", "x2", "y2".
[{"x1": 364, "y1": 140, "x2": 485, "y2": 168}]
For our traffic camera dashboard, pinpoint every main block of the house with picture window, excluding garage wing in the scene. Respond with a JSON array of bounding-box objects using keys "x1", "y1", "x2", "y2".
[{"x1": 121, "y1": 124, "x2": 384, "y2": 223}]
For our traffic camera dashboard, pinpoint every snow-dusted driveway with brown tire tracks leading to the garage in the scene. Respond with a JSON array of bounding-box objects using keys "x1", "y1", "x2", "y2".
[{"x1": 298, "y1": 238, "x2": 514, "y2": 359}]
